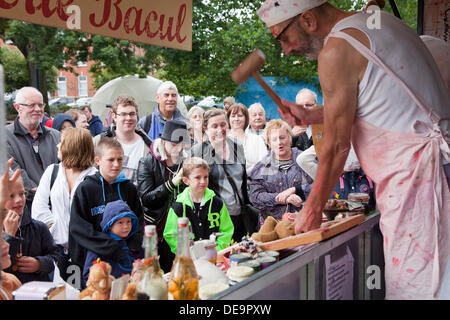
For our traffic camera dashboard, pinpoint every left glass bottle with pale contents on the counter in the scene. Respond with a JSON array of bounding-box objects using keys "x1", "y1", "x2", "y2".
[{"x1": 136, "y1": 225, "x2": 168, "y2": 300}]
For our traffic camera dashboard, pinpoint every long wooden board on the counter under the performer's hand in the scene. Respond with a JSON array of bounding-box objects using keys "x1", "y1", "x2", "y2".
[{"x1": 256, "y1": 214, "x2": 366, "y2": 251}]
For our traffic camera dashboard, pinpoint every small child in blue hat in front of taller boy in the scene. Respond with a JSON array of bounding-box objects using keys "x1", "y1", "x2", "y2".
[{"x1": 83, "y1": 200, "x2": 142, "y2": 281}]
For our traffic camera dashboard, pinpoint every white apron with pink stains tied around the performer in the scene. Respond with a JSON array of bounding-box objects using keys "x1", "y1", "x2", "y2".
[{"x1": 328, "y1": 31, "x2": 450, "y2": 299}]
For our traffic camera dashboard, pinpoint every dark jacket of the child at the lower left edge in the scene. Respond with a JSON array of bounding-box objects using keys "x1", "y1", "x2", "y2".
[{"x1": 3, "y1": 206, "x2": 59, "y2": 283}]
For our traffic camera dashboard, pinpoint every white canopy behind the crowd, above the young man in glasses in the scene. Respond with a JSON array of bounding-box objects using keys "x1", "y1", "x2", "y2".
[{"x1": 90, "y1": 76, "x2": 187, "y2": 121}]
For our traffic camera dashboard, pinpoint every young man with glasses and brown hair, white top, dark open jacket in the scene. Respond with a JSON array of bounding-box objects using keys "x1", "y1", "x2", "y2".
[{"x1": 94, "y1": 95, "x2": 152, "y2": 186}]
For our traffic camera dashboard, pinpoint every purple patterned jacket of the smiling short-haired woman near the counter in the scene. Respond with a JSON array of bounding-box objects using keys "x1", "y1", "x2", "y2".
[{"x1": 248, "y1": 148, "x2": 313, "y2": 219}]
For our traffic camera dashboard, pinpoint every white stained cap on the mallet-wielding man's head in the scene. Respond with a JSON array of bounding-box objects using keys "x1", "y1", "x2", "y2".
[{"x1": 258, "y1": 0, "x2": 328, "y2": 30}]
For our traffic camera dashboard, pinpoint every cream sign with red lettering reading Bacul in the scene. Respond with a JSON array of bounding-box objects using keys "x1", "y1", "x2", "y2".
[{"x1": 0, "y1": 0, "x2": 192, "y2": 51}]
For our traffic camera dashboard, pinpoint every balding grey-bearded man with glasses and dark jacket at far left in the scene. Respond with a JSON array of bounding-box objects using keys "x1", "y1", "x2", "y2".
[{"x1": 6, "y1": 87, "x2": 60, "y2": 203}]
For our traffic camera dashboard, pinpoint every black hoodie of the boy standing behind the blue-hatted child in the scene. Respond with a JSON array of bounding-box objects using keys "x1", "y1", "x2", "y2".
[{"x1": 69, "y1": 172, "x2": 143, "y2": 268}]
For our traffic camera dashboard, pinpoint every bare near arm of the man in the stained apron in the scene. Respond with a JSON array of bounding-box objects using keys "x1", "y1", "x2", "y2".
[{"x1": 296, "y1": 34, "x2": 364, "y2": 233}]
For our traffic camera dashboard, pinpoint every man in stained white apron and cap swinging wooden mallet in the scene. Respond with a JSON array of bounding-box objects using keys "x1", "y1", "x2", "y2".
[{"x1": 258, "y1": 0, "x2": 450, "y2": 299}]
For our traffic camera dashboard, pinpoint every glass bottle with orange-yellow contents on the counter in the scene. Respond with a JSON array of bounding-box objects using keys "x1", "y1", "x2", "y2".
[{"x1": 169, "y1": 217, "x2": 198, "y2": 300}]
